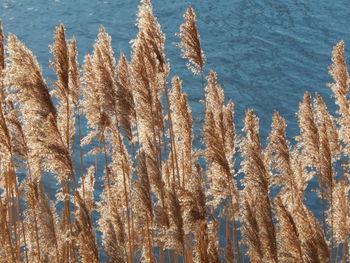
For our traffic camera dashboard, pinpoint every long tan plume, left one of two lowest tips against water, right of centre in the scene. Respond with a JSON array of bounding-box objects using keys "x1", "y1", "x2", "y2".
[{"x1": 241, "y1": 110, "x2": 277, "y2": 262}]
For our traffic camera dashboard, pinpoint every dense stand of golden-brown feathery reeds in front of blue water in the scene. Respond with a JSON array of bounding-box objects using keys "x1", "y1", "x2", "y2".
[{"x1": 0, "y1": 0, "x2": 350, "y2": 263}]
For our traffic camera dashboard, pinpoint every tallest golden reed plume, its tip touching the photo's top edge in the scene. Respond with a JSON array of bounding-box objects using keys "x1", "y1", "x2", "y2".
[{"x1": 131, "y1": 0, "x2": 169, "y2": 159}]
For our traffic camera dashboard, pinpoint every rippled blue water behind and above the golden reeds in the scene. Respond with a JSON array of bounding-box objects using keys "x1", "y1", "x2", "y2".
[{"x1": 0, "y1": 0, "x2": 350, "y2": 262}]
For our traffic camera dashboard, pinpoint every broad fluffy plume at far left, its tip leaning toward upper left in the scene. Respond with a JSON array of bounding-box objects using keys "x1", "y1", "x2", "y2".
[{"x1": 5, "y1": 34, "x2": 56, "y2": 177}]
